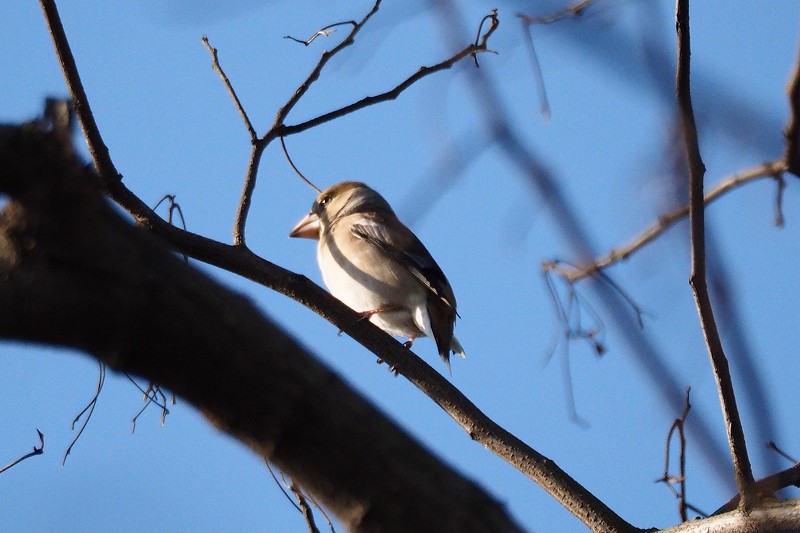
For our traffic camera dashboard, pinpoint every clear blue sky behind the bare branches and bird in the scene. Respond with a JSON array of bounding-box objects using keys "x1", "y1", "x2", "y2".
[{"x1": 0, "y1": 0, "x2": 800, "y2": 532}]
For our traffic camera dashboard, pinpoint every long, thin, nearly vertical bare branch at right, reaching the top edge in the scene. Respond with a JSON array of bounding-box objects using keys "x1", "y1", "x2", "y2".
[{"x1": 675, "y1": 0, "x2": 755, "y2": 512}]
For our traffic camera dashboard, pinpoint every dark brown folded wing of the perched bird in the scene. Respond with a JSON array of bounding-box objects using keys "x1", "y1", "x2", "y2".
[{"x1": 351, "y1": 218, "x2": 456, "y2": 311}]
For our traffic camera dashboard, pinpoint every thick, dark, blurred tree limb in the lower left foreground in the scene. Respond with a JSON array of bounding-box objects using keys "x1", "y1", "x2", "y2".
[{"x1": 0, "y1": 119, "x2": 519, "y2": 532}]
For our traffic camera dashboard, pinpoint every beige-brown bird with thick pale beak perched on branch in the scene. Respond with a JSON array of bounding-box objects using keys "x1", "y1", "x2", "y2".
[{"x1": 289, "y1": 181, "x2": 465, "y2": 371}]
